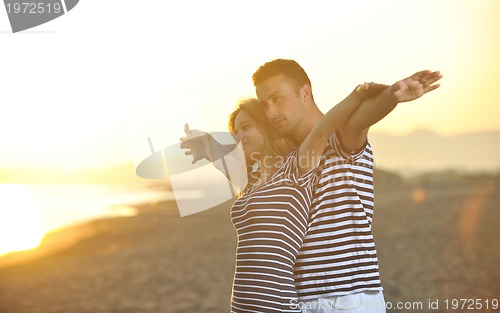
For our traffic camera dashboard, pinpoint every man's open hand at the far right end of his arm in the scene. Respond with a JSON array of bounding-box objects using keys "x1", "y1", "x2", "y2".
[{"x1": 388, "y1": 71, "x2": 443, "y2": 103}]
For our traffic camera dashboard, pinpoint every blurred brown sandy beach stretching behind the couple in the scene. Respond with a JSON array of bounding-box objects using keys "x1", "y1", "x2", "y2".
[{"x1": 0, "y1": 177, "x2": 500, "y2": 313}]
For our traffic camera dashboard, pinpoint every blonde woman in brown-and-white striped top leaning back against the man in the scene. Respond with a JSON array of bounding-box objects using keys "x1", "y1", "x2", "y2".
[{"x1": 181, "y1": 84, "x2": 380, "y2": 312}]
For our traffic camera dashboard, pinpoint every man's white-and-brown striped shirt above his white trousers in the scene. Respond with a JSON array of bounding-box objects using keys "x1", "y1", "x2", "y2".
[{"x1": 294, "y1": 133, "x2": 382, "y2": 301}]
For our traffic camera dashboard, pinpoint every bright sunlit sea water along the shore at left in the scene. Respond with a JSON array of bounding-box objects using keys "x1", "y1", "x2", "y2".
[{"x1": 0, "y1": 184, "x2": 175, "y2": 255}]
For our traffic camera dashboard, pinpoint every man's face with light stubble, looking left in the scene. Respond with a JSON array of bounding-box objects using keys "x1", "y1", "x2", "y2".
[{"x1": 256, "y1": 74, "x2": 305, "y2": 136}]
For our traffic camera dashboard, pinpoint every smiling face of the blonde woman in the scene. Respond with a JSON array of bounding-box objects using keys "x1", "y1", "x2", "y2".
[{"x1": 234, "y1": 110, "x2": 266, "y2": 160}]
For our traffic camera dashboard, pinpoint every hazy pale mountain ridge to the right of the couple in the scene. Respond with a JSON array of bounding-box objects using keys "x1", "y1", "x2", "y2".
[{"x1": 369, "y1": 130, "x2": 500, "y2": 176}]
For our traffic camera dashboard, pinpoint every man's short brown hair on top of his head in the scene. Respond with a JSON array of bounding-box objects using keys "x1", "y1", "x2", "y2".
[{"x1": 252, "y1": 59, "x2": 312, "y2": 90}]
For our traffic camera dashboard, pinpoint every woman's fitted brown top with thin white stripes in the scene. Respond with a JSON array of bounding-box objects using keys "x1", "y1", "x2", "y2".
[{"x1": 231, "y1": 151, "x2": 314, "y2": 313}]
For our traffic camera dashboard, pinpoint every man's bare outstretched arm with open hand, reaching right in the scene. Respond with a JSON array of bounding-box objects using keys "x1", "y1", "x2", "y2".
[{"x1": 339, "y1": 71, "x2": 443, "y2": 152}]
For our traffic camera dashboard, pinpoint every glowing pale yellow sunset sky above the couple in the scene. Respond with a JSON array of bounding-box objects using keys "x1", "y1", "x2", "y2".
[{"x1": 0, "y1": 0, "x2": 500, "y2": 171}]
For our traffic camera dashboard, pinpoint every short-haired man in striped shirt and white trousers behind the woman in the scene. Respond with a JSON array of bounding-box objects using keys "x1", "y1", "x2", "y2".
[{"x1": 252, "y1": 59, "x2": 442, "y2": 313}]
